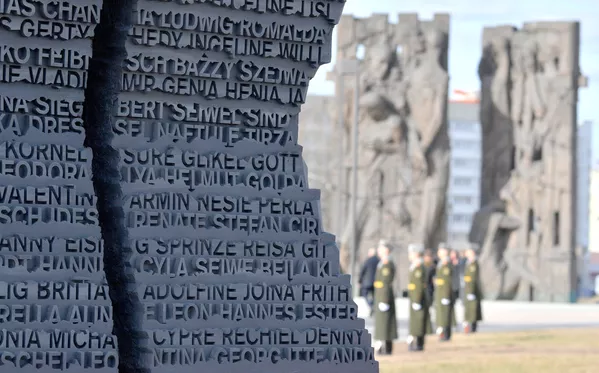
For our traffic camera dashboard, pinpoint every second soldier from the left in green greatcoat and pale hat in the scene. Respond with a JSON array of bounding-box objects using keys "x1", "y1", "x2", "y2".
[{"x1": 407, "y1": 244, "x2": 432, "y2": 351}]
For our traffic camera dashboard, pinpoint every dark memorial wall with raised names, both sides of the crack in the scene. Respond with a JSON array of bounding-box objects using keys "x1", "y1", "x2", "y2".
[{"x1": 0, "y1": 0, "x2": 378, "y2": 373}]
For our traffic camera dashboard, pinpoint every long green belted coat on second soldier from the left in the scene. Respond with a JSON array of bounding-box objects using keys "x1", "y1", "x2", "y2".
[{"x1": 408, "y1": 263, "x2": 432, "y2": 337}]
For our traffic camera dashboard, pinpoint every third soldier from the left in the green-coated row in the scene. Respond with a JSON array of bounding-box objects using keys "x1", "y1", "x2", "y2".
[{"x1": 435, "y1": 244, "x2": 455, "y2": 341}]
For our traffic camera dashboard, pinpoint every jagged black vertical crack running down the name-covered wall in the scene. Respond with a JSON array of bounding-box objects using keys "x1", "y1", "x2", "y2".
[{"x1": 83, "y1": 0, "x2": 150, "y2": 373}]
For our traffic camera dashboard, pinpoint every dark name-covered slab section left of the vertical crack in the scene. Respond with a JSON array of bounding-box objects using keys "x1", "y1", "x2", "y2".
[{"x1": 0, "y1": 0, "x2": 118, "y2": 373}]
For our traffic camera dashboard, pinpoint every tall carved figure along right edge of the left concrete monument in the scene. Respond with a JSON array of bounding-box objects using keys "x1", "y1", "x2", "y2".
[{"x1": 406, "y1": 29, "x2": 449, "y2": 247}]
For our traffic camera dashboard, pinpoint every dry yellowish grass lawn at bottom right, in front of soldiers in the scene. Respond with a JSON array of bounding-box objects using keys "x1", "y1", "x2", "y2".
[{"x1": 378, "y1": 328, "x2": 599, "y2": 373}]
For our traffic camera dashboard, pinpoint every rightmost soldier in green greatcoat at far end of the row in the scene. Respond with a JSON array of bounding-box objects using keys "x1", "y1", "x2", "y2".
[{"x1": 464, "y1": 243, "x2": 483, "y2": 333}]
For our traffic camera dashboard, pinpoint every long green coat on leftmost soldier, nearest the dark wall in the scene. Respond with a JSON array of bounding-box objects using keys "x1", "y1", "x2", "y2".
[{"x1": 374, "y1": 261, "x2": 397, "y2": 341}]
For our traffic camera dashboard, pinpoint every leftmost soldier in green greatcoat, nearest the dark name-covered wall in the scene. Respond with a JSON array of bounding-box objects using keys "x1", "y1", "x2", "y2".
[{"x1": 374, "y1": 241, "x2": 397, "y2": 355}]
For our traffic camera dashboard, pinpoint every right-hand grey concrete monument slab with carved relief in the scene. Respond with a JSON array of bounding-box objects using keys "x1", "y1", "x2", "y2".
[{"x1": 471, "y1": 22, "x2": 580, "y2": 300}]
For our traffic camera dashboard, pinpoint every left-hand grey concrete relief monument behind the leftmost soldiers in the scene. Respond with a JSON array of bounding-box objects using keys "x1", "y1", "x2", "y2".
[{"x1": 337, "y1": 14, "x2": 449, "y2": 284}]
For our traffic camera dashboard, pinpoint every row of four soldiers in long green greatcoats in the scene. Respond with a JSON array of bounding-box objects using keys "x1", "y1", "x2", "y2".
[{"x1": 373, "y1": 241, "x2": 482, "y2": 355}]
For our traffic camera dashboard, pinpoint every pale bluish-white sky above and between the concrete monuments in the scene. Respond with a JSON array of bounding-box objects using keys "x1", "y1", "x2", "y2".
[{"x1": 310, "y1": 0, "x2": 599, "y2": 128}]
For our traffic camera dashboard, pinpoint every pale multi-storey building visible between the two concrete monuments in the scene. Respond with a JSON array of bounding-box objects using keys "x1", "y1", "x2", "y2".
[{"x1": 447, "y1": 92, "x2": 482, "y2": 246}]
